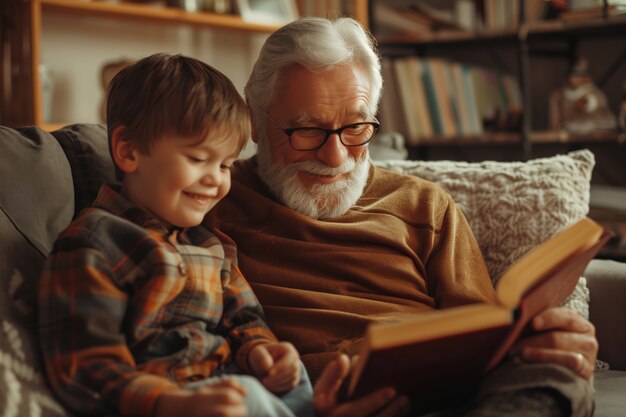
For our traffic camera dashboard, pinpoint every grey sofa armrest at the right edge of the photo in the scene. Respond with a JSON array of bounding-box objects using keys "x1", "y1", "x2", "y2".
[{"x1": 585, "y1": 259, "x2": 626, "y2": 371}]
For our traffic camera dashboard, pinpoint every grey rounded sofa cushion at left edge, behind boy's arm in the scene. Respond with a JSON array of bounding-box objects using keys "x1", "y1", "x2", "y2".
[{"x1": 0, "y1": 127, "x2": 74, "y2": 417}]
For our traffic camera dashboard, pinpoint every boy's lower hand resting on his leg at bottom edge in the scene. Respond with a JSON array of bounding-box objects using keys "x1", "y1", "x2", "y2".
[{"x1": 154, "y1": 378, "x2": 248, "y2": 417}]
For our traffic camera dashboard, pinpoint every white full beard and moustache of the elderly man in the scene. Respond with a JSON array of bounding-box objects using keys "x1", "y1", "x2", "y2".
[{"x1": 257, "y1": 138, "x2": 370, "y2": 219}]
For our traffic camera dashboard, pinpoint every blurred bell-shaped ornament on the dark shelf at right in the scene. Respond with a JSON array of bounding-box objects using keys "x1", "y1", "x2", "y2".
[{"x1": 550, "y1": 57, "x2": 617, "y2": 133}]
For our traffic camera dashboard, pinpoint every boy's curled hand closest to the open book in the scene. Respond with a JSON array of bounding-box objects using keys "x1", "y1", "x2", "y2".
[{"x1": 248, "y1": 342, "x2": 300, "y2": 393}]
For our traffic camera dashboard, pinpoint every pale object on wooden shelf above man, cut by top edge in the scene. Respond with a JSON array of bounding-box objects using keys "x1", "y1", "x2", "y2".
[{"x1": 235, "y1": 0, "x2": 298, "y2": 25}]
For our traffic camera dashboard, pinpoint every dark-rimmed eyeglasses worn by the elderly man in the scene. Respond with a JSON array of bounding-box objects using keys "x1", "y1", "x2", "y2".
[{"x1": 261, "y1": 110, "x2": 380, "y2": 151}]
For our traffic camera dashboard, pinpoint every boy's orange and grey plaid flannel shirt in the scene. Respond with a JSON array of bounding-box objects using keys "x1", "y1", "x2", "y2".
[{"x1": 39, "y1": 186, "x2": 276, "y2": 416}]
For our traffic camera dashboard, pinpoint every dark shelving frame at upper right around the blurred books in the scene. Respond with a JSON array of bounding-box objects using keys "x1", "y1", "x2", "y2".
[{"x1": 370, "y1": 0, "x2": 626, "y2": 160}]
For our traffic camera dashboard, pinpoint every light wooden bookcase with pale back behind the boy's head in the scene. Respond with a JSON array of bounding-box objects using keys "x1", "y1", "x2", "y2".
[{"x1": 0, "y1": 0, "x2": 369, "y2": 130}]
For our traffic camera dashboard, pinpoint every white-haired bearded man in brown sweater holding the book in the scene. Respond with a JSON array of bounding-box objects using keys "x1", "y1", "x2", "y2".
[{"x1": 205, "y1": 18, "x2": 597, "y2": 417}]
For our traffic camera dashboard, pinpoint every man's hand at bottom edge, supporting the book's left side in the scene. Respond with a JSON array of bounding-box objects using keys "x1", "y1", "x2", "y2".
[{"x1": 313, "y1": 355, "x2": 409, "y2": 417}]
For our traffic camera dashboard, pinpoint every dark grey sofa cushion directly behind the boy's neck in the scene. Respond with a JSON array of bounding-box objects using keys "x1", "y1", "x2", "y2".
[{"x1": 52, "y1": 123, "x2": 115, "y2": 217}]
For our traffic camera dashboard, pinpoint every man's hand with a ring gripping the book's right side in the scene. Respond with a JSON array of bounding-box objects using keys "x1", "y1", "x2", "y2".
[{"x1": 513, "y1": 307, "x2": 598, "y2": 380}]
